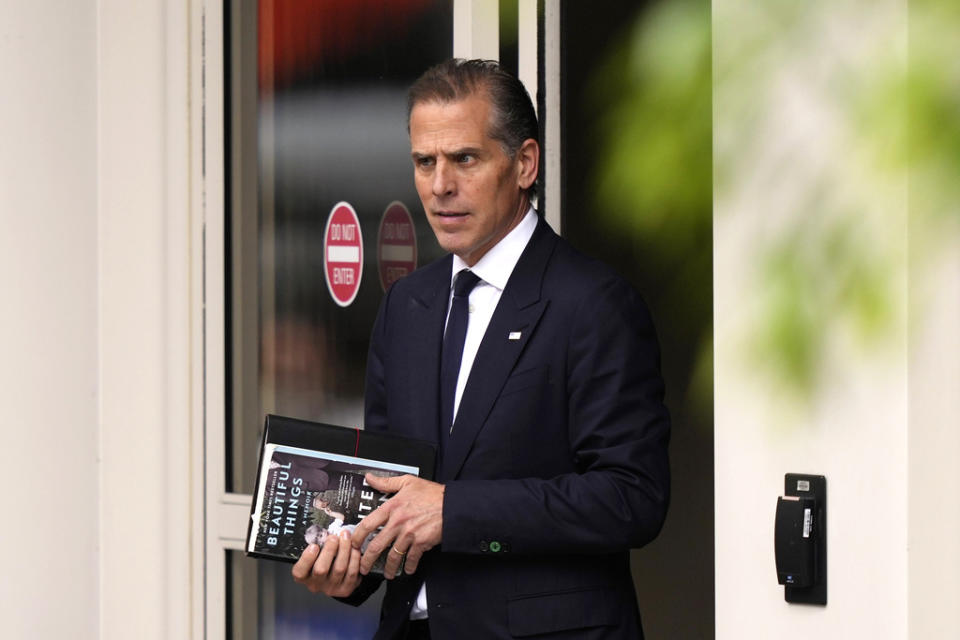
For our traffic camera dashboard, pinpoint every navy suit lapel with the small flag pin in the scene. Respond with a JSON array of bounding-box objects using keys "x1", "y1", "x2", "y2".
[{"x1": 434, "y1": 219, "x2": 557, "y2": 480}]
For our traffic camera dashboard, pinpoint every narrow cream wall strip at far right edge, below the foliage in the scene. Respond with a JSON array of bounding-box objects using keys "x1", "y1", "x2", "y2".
[{"x1": 907, "y1": 241, "x2": 960, "y2": 639}]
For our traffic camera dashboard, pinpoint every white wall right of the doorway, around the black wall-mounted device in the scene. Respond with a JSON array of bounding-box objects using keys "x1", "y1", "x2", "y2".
[{"x1": 713, "y1": 0, "x2": 960, "y2": 640}]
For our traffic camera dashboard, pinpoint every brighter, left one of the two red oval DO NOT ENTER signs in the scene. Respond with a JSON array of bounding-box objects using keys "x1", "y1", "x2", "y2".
[{"x1": 323, "y1": 202, "x2": 363, "y2": 307}]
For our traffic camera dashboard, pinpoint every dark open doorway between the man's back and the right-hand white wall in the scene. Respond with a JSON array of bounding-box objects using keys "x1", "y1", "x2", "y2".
[{"x1": 560, "y1": 0, "x2": 714, "y2": 638}]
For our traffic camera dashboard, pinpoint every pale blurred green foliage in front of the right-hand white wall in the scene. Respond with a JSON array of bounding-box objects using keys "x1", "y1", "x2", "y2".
[{"x1": 713, "y1": 0, "x2": 960, "y2": 400}]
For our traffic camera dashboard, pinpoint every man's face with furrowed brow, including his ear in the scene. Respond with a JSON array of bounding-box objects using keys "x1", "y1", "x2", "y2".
[{"x1": 410, "y1": 94, "x2": 539, "y2": 266}]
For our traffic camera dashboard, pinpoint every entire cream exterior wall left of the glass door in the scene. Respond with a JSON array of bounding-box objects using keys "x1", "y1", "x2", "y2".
[{"x1": 0, "y1": 0, "x2": 197, "y2": 640}]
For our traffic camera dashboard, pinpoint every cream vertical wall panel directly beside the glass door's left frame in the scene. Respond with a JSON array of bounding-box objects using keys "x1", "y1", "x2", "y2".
[{"x1": 97, "y1": 0, "x2": 202, "y2": 639}]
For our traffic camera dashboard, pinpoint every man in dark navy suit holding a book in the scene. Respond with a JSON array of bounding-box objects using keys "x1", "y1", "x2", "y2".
[{"x1": 293, "y1": 60, "x2": 669, "y2": 639}]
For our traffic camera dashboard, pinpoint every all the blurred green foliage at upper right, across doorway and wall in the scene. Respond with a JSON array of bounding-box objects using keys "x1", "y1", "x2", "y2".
[{"x1": 568, "y1": 0, "x2": 960, "y2": 399}]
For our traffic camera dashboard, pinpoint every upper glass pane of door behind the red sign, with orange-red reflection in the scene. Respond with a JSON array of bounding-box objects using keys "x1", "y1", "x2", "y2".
[{"x1": 226, "y1": 0, "x2": 453, "y2": 493}]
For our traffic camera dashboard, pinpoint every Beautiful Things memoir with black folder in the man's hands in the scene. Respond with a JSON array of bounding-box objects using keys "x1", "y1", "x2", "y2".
[{"x1": 246, "y1": 415, "x2": 436, "y2": 573}]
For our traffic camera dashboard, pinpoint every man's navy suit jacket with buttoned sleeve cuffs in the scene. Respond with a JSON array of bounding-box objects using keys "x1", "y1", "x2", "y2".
[{"x1": 350, "y1": 219, "x2": 670, "y2": 639}]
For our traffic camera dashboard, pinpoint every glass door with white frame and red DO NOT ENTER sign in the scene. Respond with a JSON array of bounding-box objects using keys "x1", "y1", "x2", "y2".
[{"x1": 215, "y1": 0, "x2": 552, "y2": 640}]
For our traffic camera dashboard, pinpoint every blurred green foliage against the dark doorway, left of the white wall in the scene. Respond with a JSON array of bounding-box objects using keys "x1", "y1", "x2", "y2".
[{"x1": 587, "y1": 0, "x2": 713, "y2": 257}]
